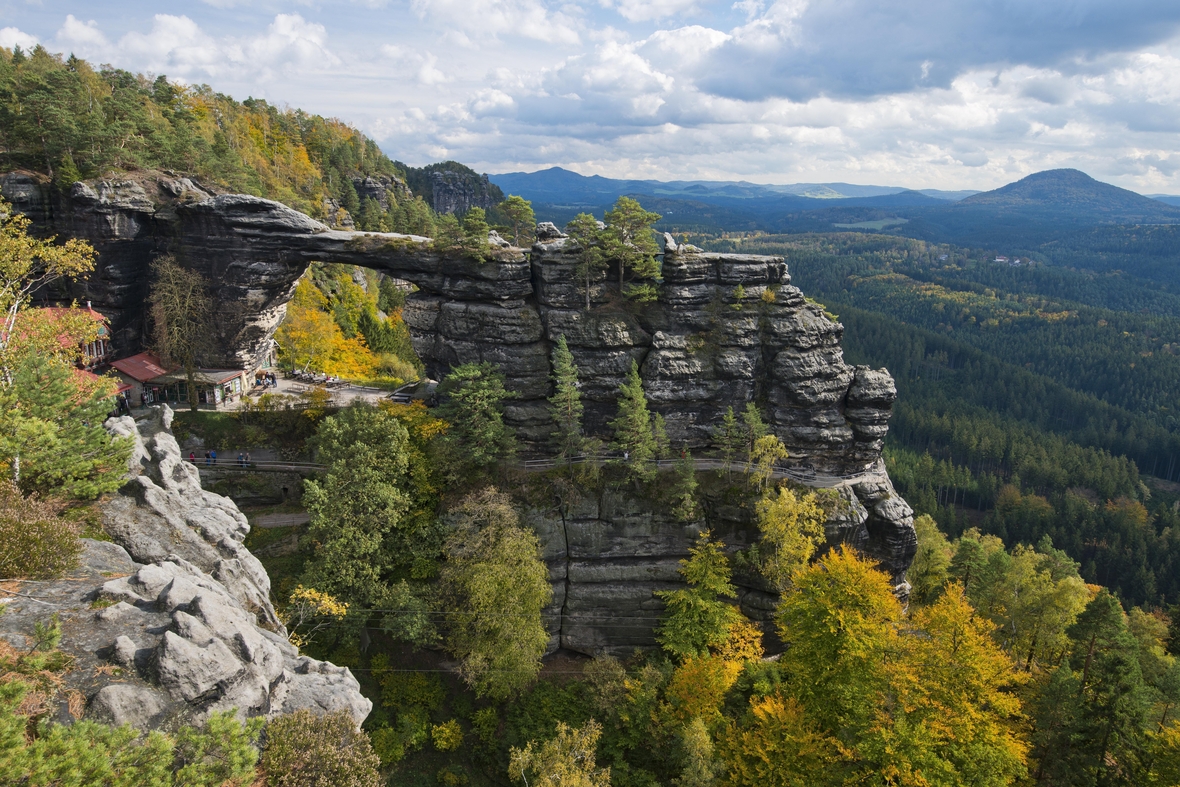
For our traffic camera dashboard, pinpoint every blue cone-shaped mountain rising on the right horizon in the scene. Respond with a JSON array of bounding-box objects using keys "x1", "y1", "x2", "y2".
[{"x1": 956, "y1": 170, "x2": 1180, "y2": 222}]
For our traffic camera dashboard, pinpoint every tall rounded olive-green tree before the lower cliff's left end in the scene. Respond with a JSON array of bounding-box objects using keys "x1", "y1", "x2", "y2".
[{"x1": 440, "y1": 488, "x2": 553, "y2": 700}]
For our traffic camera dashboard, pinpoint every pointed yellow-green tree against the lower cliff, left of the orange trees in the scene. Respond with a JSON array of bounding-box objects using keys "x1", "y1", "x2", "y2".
[{"x1": 656, "y1": 531, "x2": 742, "y2": 660}]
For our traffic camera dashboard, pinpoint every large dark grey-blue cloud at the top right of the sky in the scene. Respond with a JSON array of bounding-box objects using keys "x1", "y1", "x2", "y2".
[{"x1": 701, "y1": 0, "x2": 1180, "y2": 100}]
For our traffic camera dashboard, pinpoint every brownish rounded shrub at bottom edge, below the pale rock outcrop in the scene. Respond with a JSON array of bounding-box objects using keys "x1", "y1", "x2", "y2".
[{"x1": 261, "y1": 710, "x2": 381, "y2": 787}]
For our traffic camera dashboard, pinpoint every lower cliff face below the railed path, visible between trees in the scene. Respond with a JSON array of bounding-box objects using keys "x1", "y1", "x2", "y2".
[{"x1": 523, "y1": 465, "x2": 917, "y2": 655}]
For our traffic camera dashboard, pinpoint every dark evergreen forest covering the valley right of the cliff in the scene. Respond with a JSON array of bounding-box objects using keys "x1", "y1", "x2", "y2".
[{"x1": 709, "y1": 234, "x2": 1180, "y2": 603}]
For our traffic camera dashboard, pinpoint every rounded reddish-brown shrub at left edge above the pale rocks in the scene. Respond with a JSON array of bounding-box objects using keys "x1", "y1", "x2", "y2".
[{"x1": 0, "y1": 481, "x2": 81, "y2": 579}]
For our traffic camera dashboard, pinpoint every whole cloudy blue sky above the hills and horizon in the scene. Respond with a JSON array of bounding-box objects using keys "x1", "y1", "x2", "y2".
[{"x1": 0, "y1": 0, "x2": 1180, "y2": 194}]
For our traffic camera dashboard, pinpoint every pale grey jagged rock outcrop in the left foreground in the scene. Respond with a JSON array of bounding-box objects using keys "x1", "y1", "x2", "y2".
[{"x1": 0, "y1": 406, "x2": 372, "y2": 729}]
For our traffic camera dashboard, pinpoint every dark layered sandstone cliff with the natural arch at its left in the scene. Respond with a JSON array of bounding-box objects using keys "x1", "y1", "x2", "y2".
[{"x1": 0, "y1": 172, "x2": 916, "y2": 650}]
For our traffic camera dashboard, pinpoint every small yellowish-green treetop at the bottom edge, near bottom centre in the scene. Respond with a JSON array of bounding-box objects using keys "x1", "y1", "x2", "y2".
[{"x1": 509, "y1": 720, "x2": 610, "y2": 787}]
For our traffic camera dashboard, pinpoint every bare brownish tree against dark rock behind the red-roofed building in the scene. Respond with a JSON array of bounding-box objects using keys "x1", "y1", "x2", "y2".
[{"x1": 148, "y1": 255, "x2": 212, "y2": 412}]
